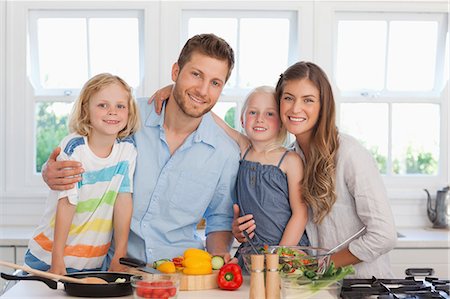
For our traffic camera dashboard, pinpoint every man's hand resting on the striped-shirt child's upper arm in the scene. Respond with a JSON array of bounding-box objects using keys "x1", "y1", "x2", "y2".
[{"x1": 42, "y1": 147, "x2": 84, "y2": 191}]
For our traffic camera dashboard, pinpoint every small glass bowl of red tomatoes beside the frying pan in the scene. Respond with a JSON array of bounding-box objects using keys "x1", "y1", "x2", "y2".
[{"x1": 131, "y1": 273, "x2": 181, "y2": 299}]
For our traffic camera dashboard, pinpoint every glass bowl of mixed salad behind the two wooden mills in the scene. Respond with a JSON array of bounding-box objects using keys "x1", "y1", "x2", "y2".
[{"x1": 239, "y1": 246, "x2": 331, "y2": 276}]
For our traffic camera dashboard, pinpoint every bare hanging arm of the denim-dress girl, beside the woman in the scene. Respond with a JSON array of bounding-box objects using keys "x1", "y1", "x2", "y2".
[{"x1": 280, "y1": 152, "x2": 308, "y2": 246}]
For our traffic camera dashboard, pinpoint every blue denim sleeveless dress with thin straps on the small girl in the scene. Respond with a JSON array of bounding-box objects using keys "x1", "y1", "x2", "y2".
[{"x1": 236, "y1": 148, "x2": 310, "y2": 269}]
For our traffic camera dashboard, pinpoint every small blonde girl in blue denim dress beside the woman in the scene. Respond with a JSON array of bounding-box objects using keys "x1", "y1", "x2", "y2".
[{"x1": 213, "y1": 86, "x2": 309, "y2": 268}]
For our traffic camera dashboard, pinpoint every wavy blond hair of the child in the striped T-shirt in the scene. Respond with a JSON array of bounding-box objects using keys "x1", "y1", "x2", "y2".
[{"x1": 69, "y1": 73, "x2": 140, "y2": 139}]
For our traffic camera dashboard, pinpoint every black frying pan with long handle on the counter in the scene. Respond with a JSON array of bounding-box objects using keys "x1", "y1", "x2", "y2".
[{"x1": 1, "y1": 271, "x2": 134, "y2": 297}]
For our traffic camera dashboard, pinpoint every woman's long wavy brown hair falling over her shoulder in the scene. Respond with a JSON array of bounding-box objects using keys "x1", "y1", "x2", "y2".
[{"x1": 276, "y1": 62, "x2": 339, "y2": 223}]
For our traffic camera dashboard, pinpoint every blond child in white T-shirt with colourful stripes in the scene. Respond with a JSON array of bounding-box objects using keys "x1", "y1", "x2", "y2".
[{"x1": 25, "y1": 73, "x2": 140, "y2": 274}]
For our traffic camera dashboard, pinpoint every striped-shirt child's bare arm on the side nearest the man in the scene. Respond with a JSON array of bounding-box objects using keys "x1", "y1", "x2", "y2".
[{"x1": 109, "y1": 193, "x2": 133, "y2": 272}]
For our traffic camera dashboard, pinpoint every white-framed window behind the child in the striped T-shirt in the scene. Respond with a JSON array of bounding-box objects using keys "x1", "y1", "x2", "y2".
[{"x1": 28, "y1": 10, "x2": 143, "y2": 172}]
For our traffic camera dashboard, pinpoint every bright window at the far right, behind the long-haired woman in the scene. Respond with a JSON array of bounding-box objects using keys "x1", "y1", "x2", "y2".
[{"x1": 334, "y1": 12, "x2": 448, "y2": 178}]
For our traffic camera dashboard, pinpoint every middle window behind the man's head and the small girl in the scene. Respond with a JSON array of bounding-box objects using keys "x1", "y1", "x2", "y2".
[{"x1": 182, "y1": 10, "x2": 298, "y2": 128}]
